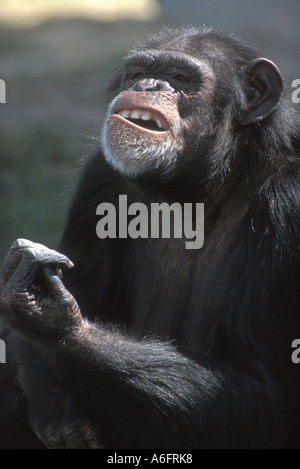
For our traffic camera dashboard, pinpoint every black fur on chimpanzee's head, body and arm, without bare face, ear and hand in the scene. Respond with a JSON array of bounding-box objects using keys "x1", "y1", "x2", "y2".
[{"x1": 0, "y1": 26, "x2": 300, "y2": 448}]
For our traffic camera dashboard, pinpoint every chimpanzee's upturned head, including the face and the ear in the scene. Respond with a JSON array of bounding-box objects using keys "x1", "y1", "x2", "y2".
[{"x1": 102, "y1": 33, "x2": 282, "y2": 177}]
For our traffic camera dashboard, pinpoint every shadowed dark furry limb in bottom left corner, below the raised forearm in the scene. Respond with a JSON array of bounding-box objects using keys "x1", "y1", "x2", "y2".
[{"x1": 0, "y1": 328, "x2": 102, "y2": 449}]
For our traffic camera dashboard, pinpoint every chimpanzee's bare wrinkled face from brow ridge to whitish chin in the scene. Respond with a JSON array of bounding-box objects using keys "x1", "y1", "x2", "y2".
[{"x1": 102, "y1": 51, "x2": 214, "y2": 177}]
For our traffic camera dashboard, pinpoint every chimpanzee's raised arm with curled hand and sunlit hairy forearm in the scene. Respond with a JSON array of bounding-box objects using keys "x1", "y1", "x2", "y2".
[{"x1": 0, "y1": 240, "x2": 280, "y2": 448}]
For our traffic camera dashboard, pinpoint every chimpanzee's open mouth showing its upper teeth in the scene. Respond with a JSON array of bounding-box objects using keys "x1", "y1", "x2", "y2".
[{"x1": 113, "y1": 108, "x2": 169, "y2": 132}]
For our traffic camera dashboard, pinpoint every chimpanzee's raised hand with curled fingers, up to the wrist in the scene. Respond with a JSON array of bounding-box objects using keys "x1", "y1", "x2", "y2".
[{"x1": 0, "y1": 239, "x2": 82, "y2": 339}]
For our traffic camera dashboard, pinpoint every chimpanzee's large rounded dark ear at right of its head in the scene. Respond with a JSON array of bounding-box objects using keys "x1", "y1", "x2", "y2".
[{"x1": 240, "y1": 59, "x2": 283, "y2": 125}]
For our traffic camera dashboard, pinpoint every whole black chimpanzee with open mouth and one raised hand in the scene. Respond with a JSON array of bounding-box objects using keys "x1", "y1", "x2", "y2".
[{"x1": 0, "y1": 28, "x2": 300, "y2": 449}]
